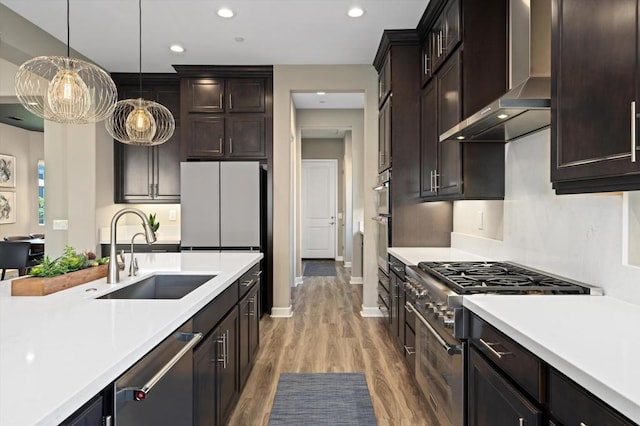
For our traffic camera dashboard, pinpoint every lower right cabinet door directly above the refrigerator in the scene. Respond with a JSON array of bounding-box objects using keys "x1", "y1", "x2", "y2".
[{"x1": 226, "y1": 115, "x2": 267, "y2": 159}]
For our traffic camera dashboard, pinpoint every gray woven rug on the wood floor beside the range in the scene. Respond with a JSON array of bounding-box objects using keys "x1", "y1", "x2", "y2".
[{"x1": 269, "y1": 373, "x2": 376, "y2": 426}]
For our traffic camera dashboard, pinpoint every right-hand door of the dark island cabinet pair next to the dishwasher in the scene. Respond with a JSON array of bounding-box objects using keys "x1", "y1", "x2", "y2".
[{"x1": 216, "y1": 309, "x2": 239, "y2": 425}]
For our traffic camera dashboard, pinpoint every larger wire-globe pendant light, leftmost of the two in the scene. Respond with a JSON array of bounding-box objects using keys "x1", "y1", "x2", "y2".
[{"x1": 15, "y1": 0, "x2": 118, "y2": 124}]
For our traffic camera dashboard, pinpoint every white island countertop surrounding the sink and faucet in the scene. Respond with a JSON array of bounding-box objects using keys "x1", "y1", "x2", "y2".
[{"x1": 0, "y1": 252, "x2": 262, "y2": 426}]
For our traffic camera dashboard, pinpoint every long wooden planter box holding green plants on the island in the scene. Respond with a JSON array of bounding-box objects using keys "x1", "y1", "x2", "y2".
[{"x1": 11, "y1": 264, "x2": 109, "y2": 296}]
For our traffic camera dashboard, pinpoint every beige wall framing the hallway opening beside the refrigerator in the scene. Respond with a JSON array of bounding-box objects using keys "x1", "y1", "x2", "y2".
[{"x1": 272, "y1": 65, "x2": 378, "y2": 316}]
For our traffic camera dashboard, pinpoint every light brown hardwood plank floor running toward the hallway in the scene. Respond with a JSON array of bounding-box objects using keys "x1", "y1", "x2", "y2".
[{"x1": 229, "y1": 263, "x2": 433, "y2": 426}]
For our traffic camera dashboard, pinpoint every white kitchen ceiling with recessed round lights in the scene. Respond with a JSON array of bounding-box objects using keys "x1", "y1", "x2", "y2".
[{"x1": 0, "y1": 0, "x2": 429, "y2": 72}]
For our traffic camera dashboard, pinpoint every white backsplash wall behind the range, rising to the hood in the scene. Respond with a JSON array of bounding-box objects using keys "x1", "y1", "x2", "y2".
[{"x1": 452, "y1": 130, "x2": 640, "y2": 303}]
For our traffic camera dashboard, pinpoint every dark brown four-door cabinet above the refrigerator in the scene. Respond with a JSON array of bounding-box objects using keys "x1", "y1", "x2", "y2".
[{"x1": 175, "y1": 65, "x2": 273, "y2": 161}]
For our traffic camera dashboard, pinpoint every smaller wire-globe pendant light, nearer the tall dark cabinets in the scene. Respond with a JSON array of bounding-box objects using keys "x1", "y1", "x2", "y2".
[{"x1": 105, "y1": 0, "x2": 176, "y2": 146}]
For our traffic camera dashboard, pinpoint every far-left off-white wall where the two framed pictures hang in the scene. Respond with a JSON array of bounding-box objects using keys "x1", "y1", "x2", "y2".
[{"x1": 0, "y1": 123, "x2": 46, "y2": 238}]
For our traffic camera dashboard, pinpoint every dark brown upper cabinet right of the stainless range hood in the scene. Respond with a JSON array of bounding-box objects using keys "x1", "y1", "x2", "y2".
[{"x1": 551, "y1": 0, "x2": 640, "y2": 194}]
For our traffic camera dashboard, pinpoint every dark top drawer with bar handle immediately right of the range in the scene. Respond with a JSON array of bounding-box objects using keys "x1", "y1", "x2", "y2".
[{"x1": 469, "y1": 315, "x2": 545, "y2": 402}]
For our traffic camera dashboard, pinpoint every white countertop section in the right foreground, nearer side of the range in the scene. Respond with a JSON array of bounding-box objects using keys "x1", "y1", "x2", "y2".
[{"x1": 463, "y1": 295, "x2": 640, "y2": 423}]
